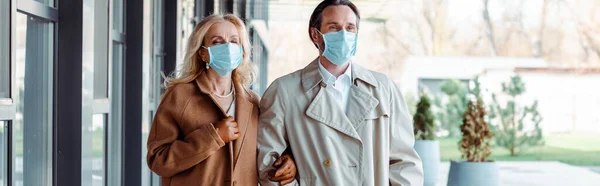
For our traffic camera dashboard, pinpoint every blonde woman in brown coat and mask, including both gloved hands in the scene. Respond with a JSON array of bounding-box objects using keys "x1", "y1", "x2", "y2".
[{"x1": 147, "y1": 14, "x2": 296, "y2": 186}]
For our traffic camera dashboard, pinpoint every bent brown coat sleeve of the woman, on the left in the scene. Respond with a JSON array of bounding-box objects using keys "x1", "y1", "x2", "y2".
[{"x1": 147, "y1": 87, "x2": 225, "y2": 177}]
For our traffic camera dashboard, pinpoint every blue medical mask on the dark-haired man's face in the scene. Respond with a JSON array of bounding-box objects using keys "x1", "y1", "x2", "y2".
[{"x1": 317, "y1": 30, "x2": 358, "y2": 66}]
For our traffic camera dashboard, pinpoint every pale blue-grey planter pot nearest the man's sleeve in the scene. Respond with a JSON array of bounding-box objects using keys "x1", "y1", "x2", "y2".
[{"x1": 415, "y1": 140, "x2": 440, "y2": 186}]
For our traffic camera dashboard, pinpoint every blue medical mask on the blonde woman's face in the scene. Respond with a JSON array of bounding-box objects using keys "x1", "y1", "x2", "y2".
[{"x1": 202, "y1": 43, "x2": 243, "y2": 76}]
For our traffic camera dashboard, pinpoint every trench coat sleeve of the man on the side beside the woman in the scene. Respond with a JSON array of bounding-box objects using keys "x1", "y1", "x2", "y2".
[{"x1": 256, "y1": 80, "x2": 296, "y2": 186}]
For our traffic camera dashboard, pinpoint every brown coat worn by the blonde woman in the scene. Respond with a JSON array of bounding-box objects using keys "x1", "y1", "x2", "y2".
[{"x1": 148, "y1": 73, "x2": 258, "y2": 186}]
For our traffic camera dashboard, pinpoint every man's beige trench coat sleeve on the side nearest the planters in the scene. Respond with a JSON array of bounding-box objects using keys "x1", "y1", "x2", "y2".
[{"x1": 389, "y1": 81, "x2": 423, "y2": 186}]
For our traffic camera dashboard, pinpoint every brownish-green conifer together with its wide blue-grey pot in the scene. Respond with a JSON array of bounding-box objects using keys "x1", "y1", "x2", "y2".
[{"x1": 448, "y1": 78, "x2": 500, "y2": 186}]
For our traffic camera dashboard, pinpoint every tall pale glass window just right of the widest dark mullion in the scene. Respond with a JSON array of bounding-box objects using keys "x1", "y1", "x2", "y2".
[{"x1": 81, "y1": 0, "x2": 109, "y2": 186}]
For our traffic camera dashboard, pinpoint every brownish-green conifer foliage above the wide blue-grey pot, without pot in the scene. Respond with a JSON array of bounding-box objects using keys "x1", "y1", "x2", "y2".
[{"x1": 460, "y1": 77, "x2": 493, "y2": 162}]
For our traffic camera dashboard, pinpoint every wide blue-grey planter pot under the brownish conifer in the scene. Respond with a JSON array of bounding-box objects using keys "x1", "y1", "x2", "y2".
[{"x1": 448, "y1": 161, "x2": 500, "y2": 186}]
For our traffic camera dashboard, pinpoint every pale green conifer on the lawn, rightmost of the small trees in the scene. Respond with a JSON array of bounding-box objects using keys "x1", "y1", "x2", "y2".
[{"x1": 489, "y1": 75, "x2": 544, "y2": 156}]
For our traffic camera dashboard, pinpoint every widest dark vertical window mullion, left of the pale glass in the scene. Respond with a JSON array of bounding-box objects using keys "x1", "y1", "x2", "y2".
[{"x1": 56, "y1": 0, "x2": 83, "y2": 185}]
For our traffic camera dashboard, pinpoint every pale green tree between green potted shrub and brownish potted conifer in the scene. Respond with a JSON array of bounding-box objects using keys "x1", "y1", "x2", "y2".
[{"x1": 433, "y1": 79, "x2": 468, "y2": 137}]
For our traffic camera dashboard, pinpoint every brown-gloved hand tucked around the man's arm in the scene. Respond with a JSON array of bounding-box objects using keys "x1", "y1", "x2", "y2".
[{"x1": 270, "y1": 154, "x2": 296, "y2": 185}]
